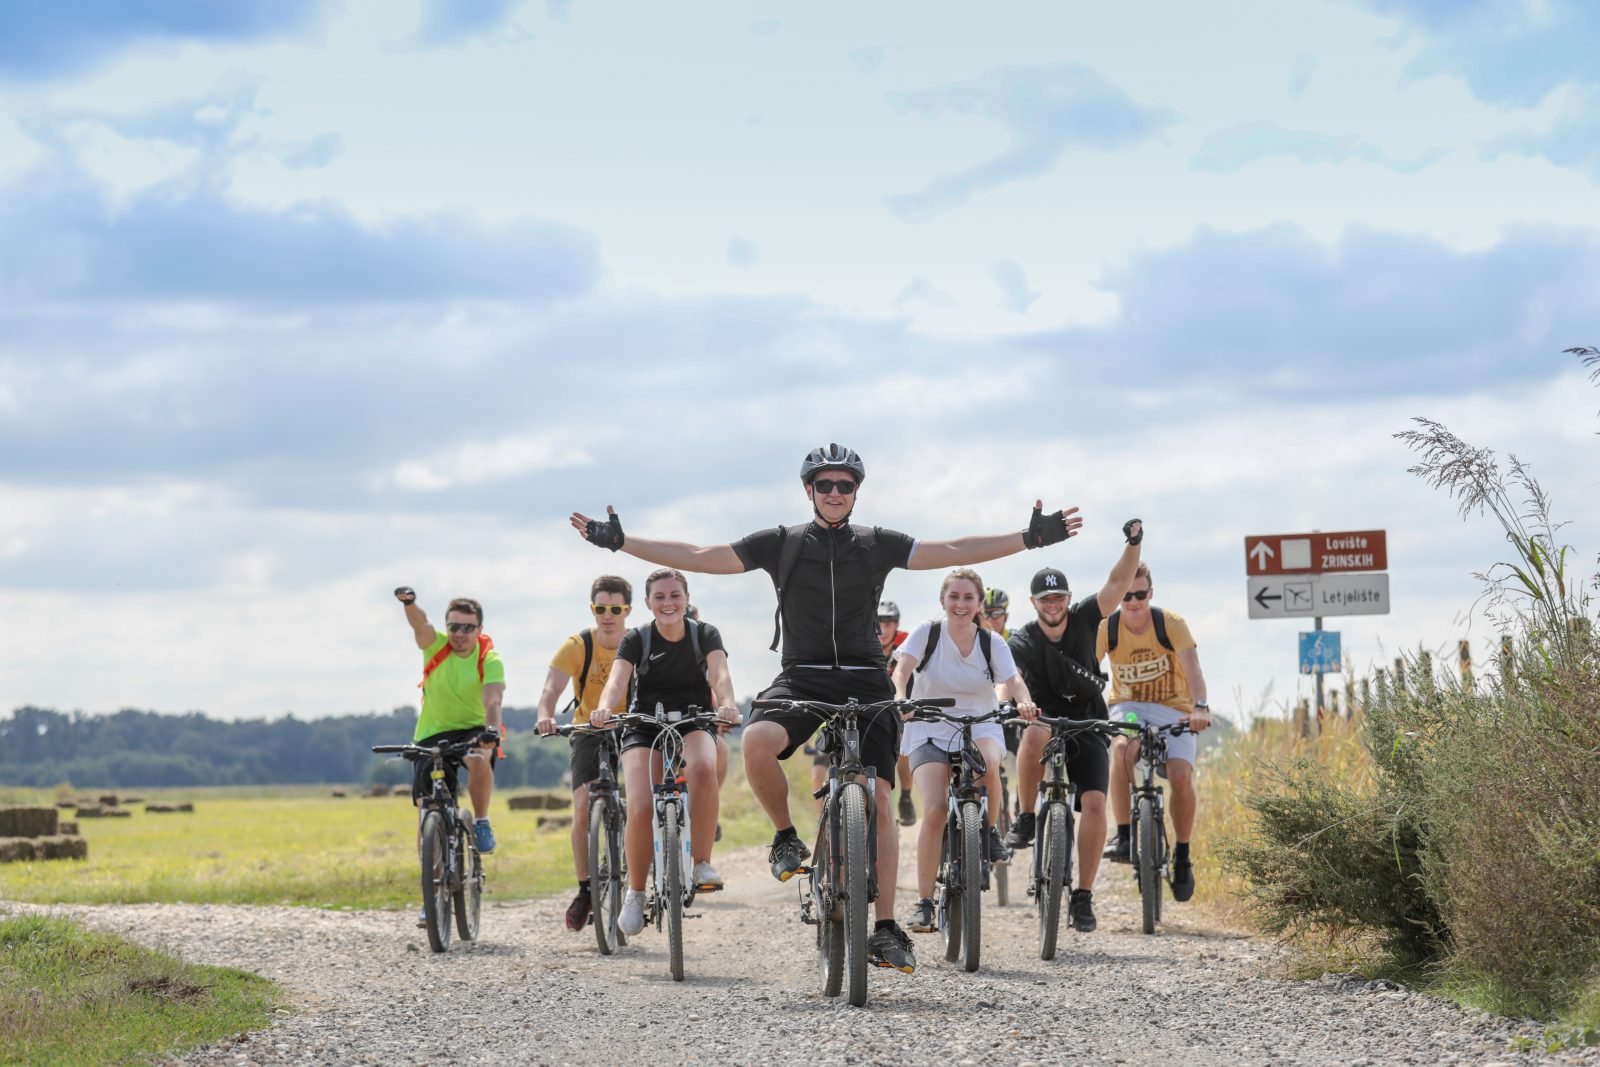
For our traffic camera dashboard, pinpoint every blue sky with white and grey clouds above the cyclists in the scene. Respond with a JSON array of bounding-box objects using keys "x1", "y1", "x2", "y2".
[{"x1": 0, "y1": 0, "x2": 1600, "y2": 717}]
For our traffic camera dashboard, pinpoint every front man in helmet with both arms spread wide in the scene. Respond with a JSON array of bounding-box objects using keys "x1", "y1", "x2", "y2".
[{"x1": 571, "y1": 445, "x2": 1083, "y2": 973}]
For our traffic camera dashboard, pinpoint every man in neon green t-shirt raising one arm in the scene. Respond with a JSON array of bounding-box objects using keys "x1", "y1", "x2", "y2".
[{"x1": 395, "y1": 585, "x2": 506, "y2": 854}]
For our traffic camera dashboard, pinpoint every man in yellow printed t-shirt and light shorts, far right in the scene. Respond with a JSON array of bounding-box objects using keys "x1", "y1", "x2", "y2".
[{"x1": 1094, "y1": 563, "x2": 1211, "y2": 901}]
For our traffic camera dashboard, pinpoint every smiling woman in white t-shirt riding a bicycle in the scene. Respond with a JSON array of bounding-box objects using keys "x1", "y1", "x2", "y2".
[{"x1": 893, "y1": 568, "x2": 1038, "y2": 934}]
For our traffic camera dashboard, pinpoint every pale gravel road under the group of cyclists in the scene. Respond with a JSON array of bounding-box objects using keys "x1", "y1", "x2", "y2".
[{"x1": 15, "y1": 838, "x2": 1600, "y2": 1067}]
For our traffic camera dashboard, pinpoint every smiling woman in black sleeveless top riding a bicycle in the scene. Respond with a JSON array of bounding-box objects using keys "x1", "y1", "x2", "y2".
[{"x1": 589, "y1": 568, "x2": 739, "y2": 936}]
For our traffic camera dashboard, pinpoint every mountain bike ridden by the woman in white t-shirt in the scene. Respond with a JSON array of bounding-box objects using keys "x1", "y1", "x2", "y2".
[{"x1": 912, "y1": 702, "x2": 1016, "y2": 973}]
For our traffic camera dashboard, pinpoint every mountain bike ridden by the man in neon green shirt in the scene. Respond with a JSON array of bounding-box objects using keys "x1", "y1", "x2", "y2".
[{"x1": 373, "y1": 737, "x2": 483, "y2": 952}]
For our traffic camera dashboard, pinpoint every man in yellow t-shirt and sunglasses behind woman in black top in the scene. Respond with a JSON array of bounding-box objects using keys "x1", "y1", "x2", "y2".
[{"x1": 534, "y1": 574, "x2": 634, "y2": 931}]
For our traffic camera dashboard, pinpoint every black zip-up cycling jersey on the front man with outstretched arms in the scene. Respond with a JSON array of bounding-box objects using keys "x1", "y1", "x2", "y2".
[{"x1": 733, "y1": 522, "x2": 917, "y2": 670}]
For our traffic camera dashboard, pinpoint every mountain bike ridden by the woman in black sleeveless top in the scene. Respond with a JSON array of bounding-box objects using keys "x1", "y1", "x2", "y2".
[{"x1": 608, "y1": 704, "x2": 720, "y2": 982}]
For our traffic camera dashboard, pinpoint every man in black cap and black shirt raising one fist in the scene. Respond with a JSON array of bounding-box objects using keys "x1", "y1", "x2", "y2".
[{"x1": 1006, "y1": 518, "x2": 1144, "y2": 934}]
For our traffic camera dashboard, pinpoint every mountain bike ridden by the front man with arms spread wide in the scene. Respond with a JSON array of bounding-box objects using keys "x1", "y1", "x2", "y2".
[{"x1": 750, "y1": 697, "x2": 955, "y2": 1008}]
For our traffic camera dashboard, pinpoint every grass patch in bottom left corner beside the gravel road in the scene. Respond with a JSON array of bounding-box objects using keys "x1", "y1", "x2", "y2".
[{"x1": 0, "y1": 915, "x2": 280, "y2": 1065}]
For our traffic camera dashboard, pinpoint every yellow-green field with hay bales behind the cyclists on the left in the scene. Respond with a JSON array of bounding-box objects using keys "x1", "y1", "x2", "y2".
[{"x1": 0, "y1": 758, "x2": 810, "y2": 909}]
